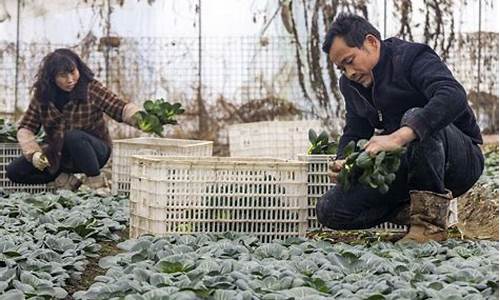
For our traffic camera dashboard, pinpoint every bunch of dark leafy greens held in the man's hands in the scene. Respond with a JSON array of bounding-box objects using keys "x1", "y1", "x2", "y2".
[{"x1": 337, "y1": 140, "x2": 406, "y2": 194}]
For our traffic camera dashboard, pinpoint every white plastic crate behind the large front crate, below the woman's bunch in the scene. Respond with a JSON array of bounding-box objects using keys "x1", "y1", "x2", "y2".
[{"x1": 111, "y1": 137, "x2": 213, "y2": 194}]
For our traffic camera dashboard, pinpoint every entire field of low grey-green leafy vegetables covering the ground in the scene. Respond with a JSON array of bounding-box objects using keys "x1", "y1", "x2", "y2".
[{"x1": 0, "y1": 147, "x2": 499, "y2": 300}]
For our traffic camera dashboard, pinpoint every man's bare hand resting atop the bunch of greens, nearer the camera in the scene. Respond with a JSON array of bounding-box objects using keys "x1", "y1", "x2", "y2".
[{"x1": 365, "y1": 126, "x2": 417, "y2": 156}]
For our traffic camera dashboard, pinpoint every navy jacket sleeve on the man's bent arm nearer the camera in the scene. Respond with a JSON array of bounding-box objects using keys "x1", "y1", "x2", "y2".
[{"x1": 401, "y1": 50, "x2": 467, "y2": 140}]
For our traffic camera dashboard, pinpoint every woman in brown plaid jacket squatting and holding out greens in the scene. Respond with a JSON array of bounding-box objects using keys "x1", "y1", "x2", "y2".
[{"x1": 7, "y1": 49, "x2": 140, "y2": 191}]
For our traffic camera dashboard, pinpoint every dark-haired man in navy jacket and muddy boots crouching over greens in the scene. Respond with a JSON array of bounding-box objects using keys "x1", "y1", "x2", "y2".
[{"x1": 316, "y1": 14, "x2": 484, "y2": 242}]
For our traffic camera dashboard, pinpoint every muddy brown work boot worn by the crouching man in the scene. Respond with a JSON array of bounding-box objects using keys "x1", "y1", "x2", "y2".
[{"x1": 401, "y1": 191, "x2": 453, "y2": 243}]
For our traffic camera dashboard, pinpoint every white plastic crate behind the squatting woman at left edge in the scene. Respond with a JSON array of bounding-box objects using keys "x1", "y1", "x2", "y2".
[{"x1": 0, "y1": 143, "x2": 49, "y2": 194}]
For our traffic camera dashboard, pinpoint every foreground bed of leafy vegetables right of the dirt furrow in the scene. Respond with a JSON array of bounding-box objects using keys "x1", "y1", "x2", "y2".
[{"x1": 73, "y1": 233, "x2": 498, "y2": 300}]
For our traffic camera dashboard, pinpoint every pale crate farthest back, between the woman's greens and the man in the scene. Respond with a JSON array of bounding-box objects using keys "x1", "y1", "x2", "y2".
[{"x1": 228, "y1": 120, "x2": 323, "y2": 159}]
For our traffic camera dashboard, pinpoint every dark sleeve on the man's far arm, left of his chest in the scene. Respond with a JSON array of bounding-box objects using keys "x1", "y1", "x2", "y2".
[{"x1": 337, "y1": 80, "x2": 374, "y2": 159}]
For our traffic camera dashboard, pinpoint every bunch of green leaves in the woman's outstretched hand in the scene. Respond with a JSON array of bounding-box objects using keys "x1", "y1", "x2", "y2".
[{"x1": 137, "y1": 98, "x2": 184, "y2": 136}]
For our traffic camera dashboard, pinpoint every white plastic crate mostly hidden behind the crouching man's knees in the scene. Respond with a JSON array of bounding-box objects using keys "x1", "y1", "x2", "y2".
[{"x1": 299, "y1": 154, "x2": 406, "y2": 231}]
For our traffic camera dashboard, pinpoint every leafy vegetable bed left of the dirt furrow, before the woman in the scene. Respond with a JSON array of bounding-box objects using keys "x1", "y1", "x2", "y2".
[{"x1": 0, "y1": 192, "x2": 128, "y2": 300}]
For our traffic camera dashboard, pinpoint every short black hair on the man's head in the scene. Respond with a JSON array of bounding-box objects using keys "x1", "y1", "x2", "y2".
[{"x1": 322, "y1": 13, "x2": 380, "y2": 54}]
